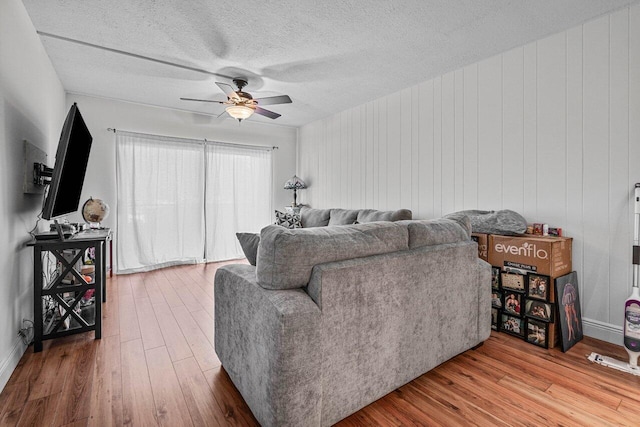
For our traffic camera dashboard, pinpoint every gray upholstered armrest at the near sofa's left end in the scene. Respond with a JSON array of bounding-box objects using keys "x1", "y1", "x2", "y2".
[{"x1": 214, "y1": 265, "x2": 322, "y2": 426}]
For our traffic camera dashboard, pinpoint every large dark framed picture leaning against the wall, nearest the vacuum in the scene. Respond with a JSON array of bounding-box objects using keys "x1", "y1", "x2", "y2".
[{"x1": 555, "y1": 271, "x2": 582, "y2": 352}]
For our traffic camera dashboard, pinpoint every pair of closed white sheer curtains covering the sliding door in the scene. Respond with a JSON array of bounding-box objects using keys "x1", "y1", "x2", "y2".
[{"x1": 115, "y1": 131, "x2": 272, "y2": 273}]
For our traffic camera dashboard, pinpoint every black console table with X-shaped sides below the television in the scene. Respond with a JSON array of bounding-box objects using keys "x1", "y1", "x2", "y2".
[{"x1": 30, "y1": 229, "x2": 113, "y2": 352}]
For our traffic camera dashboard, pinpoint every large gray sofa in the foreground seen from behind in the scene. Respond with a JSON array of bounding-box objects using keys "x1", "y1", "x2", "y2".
[{"x1": 215, "y1": 213, "x2": 491, "y2": 426}]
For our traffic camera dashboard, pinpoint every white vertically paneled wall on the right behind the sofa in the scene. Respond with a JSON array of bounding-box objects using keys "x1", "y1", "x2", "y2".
[{"x1": 299, "y1": 6, "x2": 640, "y2": 344}]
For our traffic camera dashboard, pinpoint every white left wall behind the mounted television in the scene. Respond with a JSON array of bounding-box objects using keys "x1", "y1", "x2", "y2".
[{"x1": 0, "y1": 0, "x2": 65, "y2": 390}]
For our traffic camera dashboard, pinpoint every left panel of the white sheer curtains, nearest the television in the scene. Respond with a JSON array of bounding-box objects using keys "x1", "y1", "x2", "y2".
[{"x1": 115, "y1": 131, "x2": 205, "y2": 273}]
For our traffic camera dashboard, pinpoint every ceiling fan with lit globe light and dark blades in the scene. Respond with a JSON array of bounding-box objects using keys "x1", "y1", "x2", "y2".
[{"x1": 180, "y1": 77, "x2": 292, "y2": 122}]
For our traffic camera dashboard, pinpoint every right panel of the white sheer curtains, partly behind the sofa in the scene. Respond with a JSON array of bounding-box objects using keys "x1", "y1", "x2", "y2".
[{"x1": 205, "y1": 144, "x2": 272, "y2": 261}]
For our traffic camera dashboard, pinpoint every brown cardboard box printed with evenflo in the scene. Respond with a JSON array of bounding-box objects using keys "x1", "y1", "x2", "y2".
[{"x1": 489, "y1": 234, "x2": 573, "y2": 279}]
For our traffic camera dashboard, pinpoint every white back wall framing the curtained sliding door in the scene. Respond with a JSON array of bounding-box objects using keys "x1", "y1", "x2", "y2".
[{"x1": 62, "y1": 94, "x2": 297, "y2": 270}]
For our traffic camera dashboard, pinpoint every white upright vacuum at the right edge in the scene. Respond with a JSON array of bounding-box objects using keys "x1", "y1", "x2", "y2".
[{"x1": 588, "y1": 183, "x2": 640, "y2": 376}]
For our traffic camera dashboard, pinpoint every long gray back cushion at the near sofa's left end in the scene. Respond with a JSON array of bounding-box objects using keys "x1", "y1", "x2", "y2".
[{"x1": 256, "y1": 222, "x2": 408, "y2": 289}]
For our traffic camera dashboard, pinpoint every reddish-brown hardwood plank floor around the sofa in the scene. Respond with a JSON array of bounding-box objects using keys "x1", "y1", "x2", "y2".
[{"x1": 0, "y1": 263, "x2": 640, "y2": 426}]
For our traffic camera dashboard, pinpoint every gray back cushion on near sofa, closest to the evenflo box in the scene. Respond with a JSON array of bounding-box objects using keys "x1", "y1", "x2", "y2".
[{"x1": 398, "y1": 218, "x2": 471, "y2": 249}]
